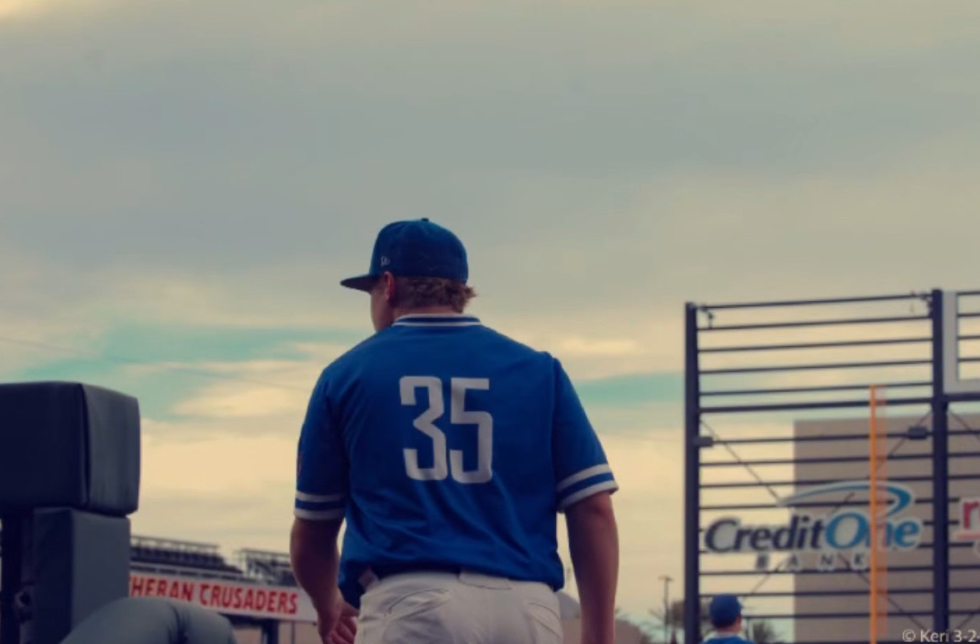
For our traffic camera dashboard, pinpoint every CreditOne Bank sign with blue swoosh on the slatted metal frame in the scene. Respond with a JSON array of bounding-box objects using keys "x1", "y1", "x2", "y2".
[{"x1": 704, "y1": 480, "x2": 923, "y2": 570}]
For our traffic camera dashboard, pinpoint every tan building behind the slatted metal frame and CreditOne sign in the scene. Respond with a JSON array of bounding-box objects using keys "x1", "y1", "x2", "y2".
[{"x1": 790, "y1": 410, "x2": 980, "y2": 642}]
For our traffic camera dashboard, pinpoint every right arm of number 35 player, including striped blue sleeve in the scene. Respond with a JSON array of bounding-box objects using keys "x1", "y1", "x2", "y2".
[{"x1": 553, "y1": 360, "x2": 619, "y2": 644}]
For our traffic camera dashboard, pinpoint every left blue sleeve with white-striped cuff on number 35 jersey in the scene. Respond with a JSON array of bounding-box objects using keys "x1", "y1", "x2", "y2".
[{"x1": 293, "y1": 372, "x2": 349, "y2": 521}]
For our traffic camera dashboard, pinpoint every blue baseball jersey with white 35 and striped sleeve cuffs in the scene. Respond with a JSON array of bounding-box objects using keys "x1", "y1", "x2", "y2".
[{"x1": 294, "y1": 315, "x2": 617, "y2": 607}]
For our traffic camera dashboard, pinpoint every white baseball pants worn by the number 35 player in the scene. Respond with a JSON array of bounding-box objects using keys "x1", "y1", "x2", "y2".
[{"x1": 355, "y1": 572, "x2": 564, "y2": 644}]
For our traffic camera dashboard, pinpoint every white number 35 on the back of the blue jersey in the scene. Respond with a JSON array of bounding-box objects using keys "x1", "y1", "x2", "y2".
[{"x1": 398, "y1": 376, "x2": 493, "y2": 483}]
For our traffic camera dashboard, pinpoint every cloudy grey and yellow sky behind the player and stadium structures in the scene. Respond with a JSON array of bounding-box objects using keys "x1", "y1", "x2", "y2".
[{"x1": 0, "y1": 0, "x2": 980, "y2": 632}]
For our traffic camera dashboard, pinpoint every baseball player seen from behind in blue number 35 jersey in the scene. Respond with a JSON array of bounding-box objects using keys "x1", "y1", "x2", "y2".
[{"x1": 290, "y1": 219, "x2": 619, "y2": 644}]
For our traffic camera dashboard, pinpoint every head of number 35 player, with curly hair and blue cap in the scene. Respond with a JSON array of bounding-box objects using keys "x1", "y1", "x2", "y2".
[{"x1": 341, "y1": 219, "x2": 476, "y2": 331}]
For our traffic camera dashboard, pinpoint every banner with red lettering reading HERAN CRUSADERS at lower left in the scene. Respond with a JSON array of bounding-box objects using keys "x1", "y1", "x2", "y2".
[{"x1": 129, "y1": 572, "x2": 316, "y2": 623}]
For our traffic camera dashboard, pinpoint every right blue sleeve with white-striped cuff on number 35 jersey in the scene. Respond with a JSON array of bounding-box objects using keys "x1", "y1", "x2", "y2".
[{"x1": 552, "y1": 360, "x2": 619, "y2": 512}]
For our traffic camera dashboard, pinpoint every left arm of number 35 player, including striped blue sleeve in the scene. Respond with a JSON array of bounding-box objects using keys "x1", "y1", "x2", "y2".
[{"x1": 289, "y1": 373, "x2": 348, "y2": 622}]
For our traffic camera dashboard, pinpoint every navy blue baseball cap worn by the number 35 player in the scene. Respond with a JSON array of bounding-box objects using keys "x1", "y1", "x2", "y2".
[{"x1": 340, "y1": 217, "x2": 469, "y2": 291}]
